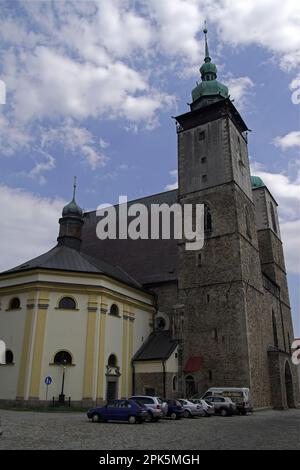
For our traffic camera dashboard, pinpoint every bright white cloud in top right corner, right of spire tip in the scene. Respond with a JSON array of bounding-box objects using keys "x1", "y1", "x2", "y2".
[{"x1": 206, "y1": 0, "x2": 300, "y2": 69}]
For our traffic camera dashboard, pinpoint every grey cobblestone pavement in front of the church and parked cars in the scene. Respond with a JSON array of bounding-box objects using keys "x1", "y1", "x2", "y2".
[{"x1": 0, "y1": 410, "x2": 300, "y2": 450}]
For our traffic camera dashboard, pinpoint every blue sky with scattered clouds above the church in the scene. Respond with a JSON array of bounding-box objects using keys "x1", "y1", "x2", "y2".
[{"x1": 0, "y1": 0, "x2": 300, "y2": 337}]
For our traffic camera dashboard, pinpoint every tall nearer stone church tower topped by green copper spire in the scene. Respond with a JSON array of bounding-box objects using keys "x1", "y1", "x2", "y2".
[{"x1": 174, "y1": 29, "x2": 270, "y2": 402}]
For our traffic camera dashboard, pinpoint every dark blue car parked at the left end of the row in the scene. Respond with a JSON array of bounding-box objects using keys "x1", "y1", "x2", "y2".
[{"x1": 87, "y1": 400, "x2": 148, "y2": 424}]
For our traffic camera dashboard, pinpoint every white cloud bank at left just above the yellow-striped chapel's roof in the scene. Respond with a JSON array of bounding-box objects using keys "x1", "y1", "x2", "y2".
[{"x1": 0, "y1": 185, "x2": 65, "y2": 270}]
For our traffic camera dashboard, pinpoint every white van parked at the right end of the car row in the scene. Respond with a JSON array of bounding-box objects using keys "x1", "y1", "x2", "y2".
[{"x1": 202, "y1": 387, "x2": 253, "y2": 415}]
